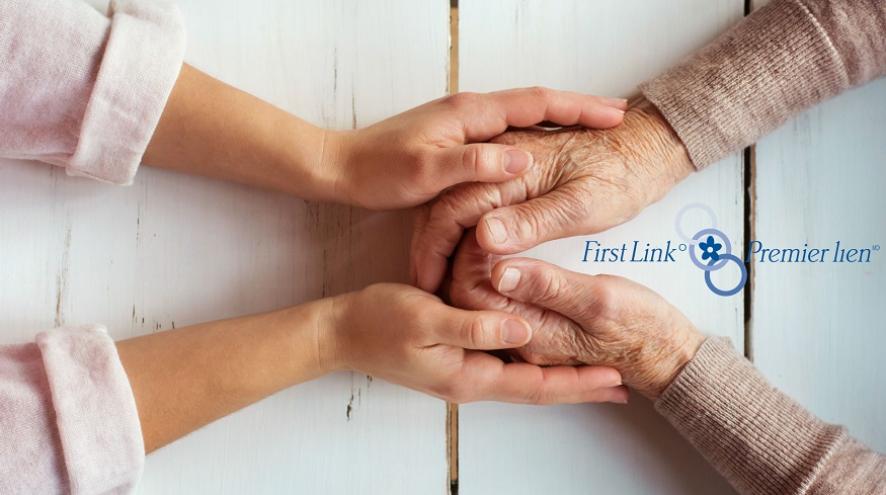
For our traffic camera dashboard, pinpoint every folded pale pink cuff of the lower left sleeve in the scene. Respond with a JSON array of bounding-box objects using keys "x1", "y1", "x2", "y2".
[{"x1": 37, "y1": 326, "x2": 144, "y2": 494}]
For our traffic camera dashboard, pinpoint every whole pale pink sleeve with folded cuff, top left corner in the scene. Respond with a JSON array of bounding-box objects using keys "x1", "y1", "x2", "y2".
[{"x1": 0, "y1": 0, "x2": 185, "y2": 184}]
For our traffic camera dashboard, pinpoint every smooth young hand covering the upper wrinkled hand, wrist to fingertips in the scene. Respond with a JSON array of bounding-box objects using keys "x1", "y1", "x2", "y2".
[{"x1": 322, "y1": 88, "x2": 627, "y2": 209}]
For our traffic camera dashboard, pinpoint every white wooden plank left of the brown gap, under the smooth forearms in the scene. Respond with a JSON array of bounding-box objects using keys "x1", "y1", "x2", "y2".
[{"x1": 0, "y1": 0, "x2": 449, "y2": 494}]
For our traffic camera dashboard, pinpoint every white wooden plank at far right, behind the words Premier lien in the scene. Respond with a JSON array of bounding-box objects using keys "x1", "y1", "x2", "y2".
[{"x1": 751, "y1": 80, "x2": 886, "y2": 451}]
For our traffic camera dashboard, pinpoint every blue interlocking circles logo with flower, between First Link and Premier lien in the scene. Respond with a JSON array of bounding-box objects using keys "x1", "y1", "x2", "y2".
[{"x1": 674, "y1": 203, "x2": 748, "y2": 296}]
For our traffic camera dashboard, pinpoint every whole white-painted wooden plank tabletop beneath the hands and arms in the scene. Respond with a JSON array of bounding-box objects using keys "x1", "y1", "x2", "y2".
[{"x1": 0, "y1": 0, "x2": 886, "y2": 495}]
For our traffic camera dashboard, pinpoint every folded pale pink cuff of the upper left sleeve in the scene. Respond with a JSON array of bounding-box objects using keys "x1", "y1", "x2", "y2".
[{"x1": 67, "y1": 0, "x2": 185, "y2": 185}]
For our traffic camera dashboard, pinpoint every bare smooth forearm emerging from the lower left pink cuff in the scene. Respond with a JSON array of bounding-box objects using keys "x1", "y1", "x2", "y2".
[{"x1": 117, "y1": 299, "x2": 330, "y2": 452}]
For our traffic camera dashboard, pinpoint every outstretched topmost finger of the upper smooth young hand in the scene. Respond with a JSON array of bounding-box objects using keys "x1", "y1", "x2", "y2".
[{"x1": 451, "y1": 87, "x2": 627, "y2": 141}]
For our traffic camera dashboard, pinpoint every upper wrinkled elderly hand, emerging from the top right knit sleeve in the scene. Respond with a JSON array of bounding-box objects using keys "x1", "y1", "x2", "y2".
[{"x1": 411, "y1": 100, "x2": 694, "y2": 291}]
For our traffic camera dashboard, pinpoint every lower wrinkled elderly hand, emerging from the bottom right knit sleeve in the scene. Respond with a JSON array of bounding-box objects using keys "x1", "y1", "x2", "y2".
[{"x1": 449, "y1": 231, "x2": 704, "y2": 399}]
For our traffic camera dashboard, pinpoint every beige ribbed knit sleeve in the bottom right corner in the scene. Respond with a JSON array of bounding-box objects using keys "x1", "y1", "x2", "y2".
[{"x1": 655, "y1": 337, "x2": 886, "y2": 495}]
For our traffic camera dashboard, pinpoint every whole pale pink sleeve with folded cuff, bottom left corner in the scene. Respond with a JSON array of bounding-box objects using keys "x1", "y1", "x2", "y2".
[{"x1": 0, "y1": 326, "x2": 144, "y2": 495}]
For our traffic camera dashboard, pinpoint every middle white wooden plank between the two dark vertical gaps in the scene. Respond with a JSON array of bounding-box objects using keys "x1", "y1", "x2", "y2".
[{"x1": 459, "y1": 0, "x2": 744, "y2": 495}]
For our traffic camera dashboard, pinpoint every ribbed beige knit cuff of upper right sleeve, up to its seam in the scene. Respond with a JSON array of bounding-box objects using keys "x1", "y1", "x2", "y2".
[{"x1": 640, "y1": 0, "x2": 849, "y2": 170}]
